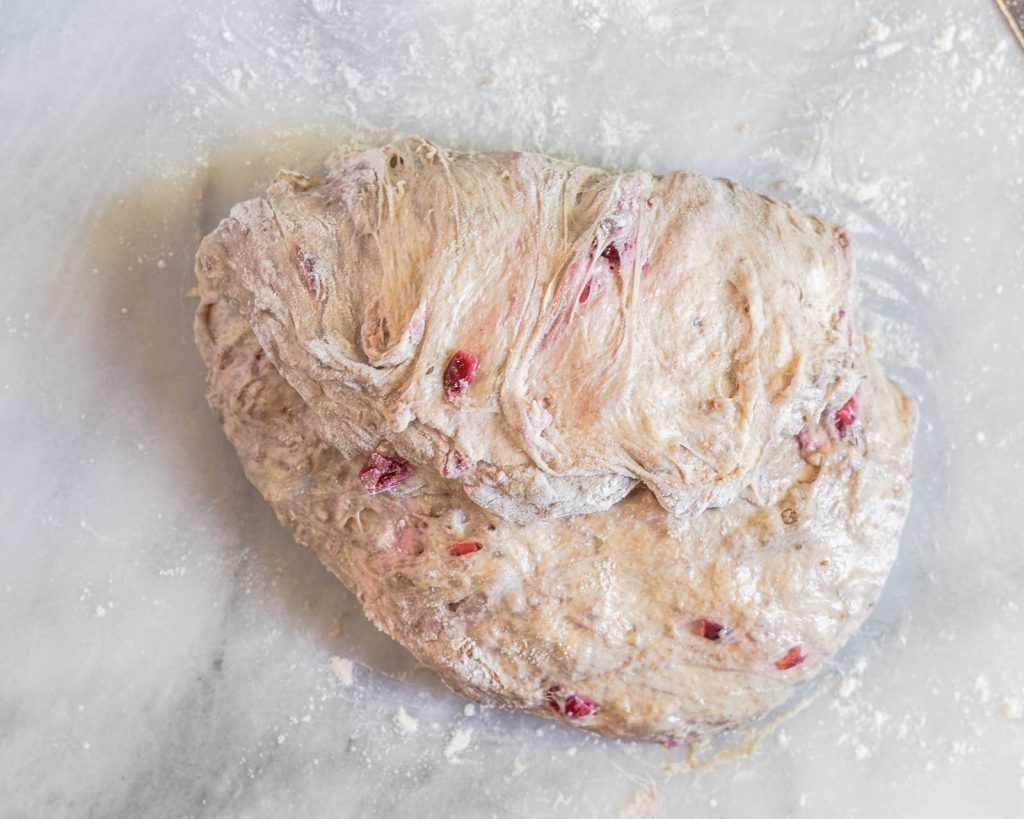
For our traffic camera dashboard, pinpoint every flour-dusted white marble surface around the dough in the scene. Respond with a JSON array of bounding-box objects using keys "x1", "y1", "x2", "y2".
[{"x1": 0, "y1": 0, "x2": 1024, "y2": 817}]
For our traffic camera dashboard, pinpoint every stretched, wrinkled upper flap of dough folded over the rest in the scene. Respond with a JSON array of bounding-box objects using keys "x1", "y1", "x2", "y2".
[{"x1": 198, "y1": 138, "x2": 864, "y2": 523}]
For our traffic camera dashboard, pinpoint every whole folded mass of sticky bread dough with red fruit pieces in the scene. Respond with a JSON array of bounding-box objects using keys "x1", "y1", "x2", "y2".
[{"x1": 196, "y1": 139, "x2": 914, "y2": 743}]
